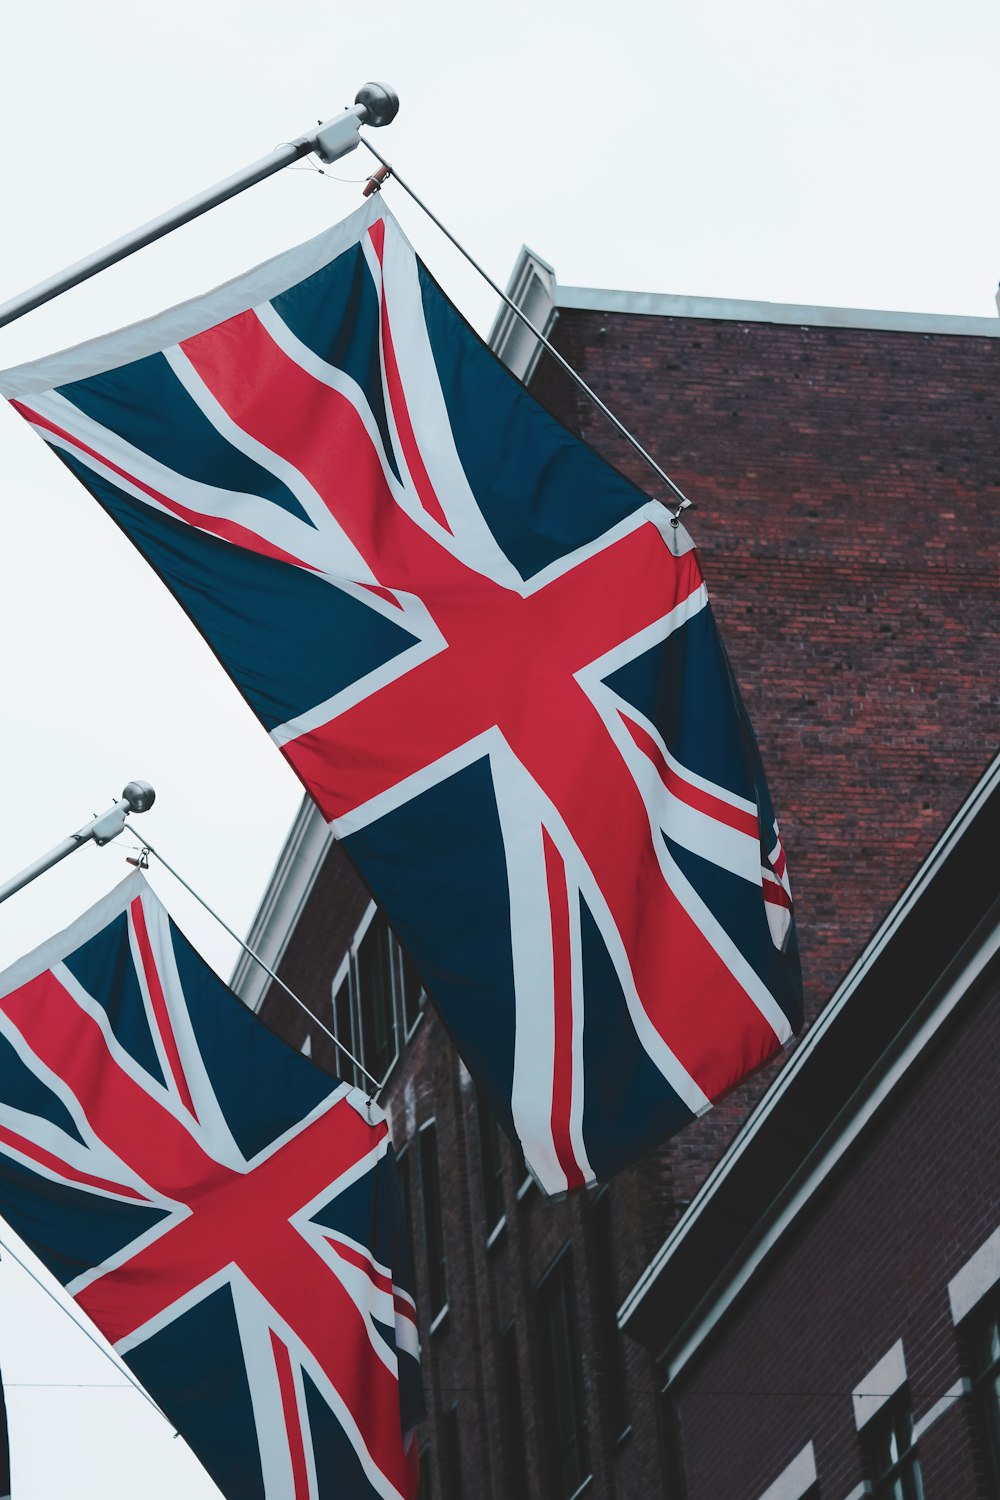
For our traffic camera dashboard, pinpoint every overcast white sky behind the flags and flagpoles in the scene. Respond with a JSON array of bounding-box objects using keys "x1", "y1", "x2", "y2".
[{"x1": 0, "y1": 0, "x2": 1000, "y2": 1500}]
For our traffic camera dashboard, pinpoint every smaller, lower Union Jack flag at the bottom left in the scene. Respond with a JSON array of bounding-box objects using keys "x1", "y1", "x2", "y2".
[{"x1": 0, "y1": 875, "x2": 421, "y2": 1500}]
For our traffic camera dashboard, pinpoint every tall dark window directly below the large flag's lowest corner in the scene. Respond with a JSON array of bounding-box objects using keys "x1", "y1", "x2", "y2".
[{"x1": 538, "y1": 1248, "x2": 591, "y2": 1500}]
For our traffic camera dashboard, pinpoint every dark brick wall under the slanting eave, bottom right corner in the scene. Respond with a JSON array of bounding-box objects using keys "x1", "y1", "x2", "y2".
[{"x1": 678, "y1": 969, "x2": 1000, "y2": 1500}]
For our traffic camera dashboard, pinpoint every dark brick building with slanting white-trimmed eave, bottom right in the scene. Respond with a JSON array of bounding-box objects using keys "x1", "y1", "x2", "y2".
[{"x1": 622, "y1": 759, "x2": 1000, "y2": 1500}]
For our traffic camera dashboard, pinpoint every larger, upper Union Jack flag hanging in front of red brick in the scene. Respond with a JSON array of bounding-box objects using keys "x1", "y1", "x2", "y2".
[{"x1": 0, "y1": 200, "x2": 801, "y2": 1194}]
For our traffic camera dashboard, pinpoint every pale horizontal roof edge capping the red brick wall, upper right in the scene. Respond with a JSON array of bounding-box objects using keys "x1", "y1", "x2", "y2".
[{"x1": 555, "y1": 282, "x2": 1000, "y2": 339}]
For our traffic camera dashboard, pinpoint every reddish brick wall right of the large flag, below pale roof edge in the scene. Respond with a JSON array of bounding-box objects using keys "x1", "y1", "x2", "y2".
[{"x1": 532, "y1": 311, "x2": 1000, "y2": 1202}]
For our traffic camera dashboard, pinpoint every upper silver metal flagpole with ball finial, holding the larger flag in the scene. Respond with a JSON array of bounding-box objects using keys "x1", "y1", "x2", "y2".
[{"x1": 0, "y1": 84, "x2": 399, "y2": 329}]
